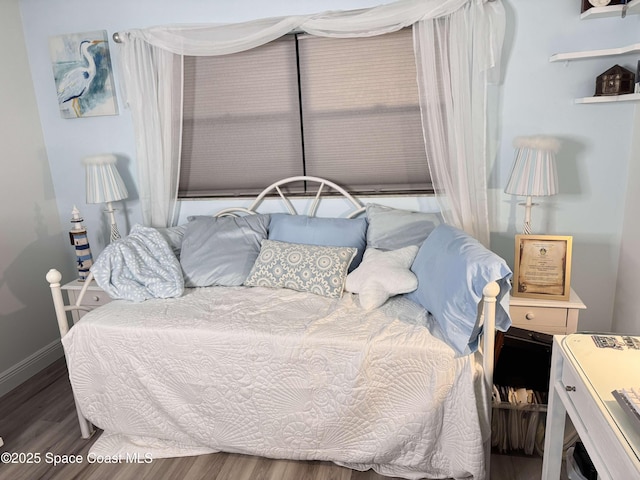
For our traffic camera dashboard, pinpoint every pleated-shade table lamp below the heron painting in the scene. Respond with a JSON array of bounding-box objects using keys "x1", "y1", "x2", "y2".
[{"x1": 82, "y1": 154, "x2": 129, "y2": 242}]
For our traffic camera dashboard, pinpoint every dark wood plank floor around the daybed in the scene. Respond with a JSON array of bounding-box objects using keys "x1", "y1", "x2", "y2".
[{"x1": 0, "y1": 359, "x2": 560, "y2": 480}]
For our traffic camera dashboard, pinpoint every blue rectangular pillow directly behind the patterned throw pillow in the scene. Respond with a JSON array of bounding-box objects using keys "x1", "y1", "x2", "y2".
[{"x1": 269, "y1": 213, "x2": 367, "y2": 272}]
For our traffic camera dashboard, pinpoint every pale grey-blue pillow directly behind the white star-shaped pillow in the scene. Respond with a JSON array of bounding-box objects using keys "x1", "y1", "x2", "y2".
[{"x1": 367, "y1": 203, "x2": 442, "y2": 250}]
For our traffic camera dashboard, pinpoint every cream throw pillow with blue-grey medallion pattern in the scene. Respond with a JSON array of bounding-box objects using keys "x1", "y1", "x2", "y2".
[{"x1": 244, "y1": 240, "x2": 357, "y2": 298}]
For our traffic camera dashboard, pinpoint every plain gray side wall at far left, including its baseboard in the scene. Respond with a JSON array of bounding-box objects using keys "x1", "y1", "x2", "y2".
[{"x1": 0, "y1": 0, "x2": 65, "y2": 395}]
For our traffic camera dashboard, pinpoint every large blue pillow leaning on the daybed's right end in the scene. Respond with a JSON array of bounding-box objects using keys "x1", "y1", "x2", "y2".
[{"x1": 405, "y1": 224, "x2": 512, "y2": 355}]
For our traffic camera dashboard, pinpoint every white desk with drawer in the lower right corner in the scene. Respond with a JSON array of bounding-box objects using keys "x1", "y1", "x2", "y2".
[{"x1": 542, "y1": 334, "x2": 640, "y2": 480}]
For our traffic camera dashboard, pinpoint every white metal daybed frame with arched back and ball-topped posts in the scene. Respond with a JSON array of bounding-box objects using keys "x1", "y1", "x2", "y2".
[{"x1": 46, "y1": 176, "x2": 500, "y2": 478}]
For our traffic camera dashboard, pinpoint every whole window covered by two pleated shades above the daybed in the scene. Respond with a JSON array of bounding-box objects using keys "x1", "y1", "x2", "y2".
[{"x1": 179, "y1": 29, "x2": 431, "y2": 197}]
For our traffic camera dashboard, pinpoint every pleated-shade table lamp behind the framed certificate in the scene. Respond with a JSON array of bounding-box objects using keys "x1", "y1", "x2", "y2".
[{"x1": 504, "y1": 136, "x2": 560, "y2": 235}]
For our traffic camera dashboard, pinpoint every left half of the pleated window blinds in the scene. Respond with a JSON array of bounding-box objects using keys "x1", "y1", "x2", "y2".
[{"x1": 179, "y1": 36, "x2": 303, "y2": 197}]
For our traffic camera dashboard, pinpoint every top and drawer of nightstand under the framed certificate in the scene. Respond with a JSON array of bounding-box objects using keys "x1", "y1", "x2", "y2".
[{"x1": 509, "y1": 289, "x2": 587, "y2": 335}]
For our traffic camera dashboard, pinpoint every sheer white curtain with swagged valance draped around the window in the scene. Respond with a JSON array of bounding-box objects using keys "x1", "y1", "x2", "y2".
[{"x1": 120, "y1": 0, "x2": 504, "y2": 234}]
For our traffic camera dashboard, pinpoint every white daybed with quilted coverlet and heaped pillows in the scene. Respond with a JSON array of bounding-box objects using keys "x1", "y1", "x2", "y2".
[{"x1": 47, "y1": 177, "x2": 510, "y2": 479}]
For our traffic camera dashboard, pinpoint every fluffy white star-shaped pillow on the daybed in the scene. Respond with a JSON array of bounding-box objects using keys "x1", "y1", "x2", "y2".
[{"x1": 345, "y1": 245, "x2": 419, "y2": 310}]
